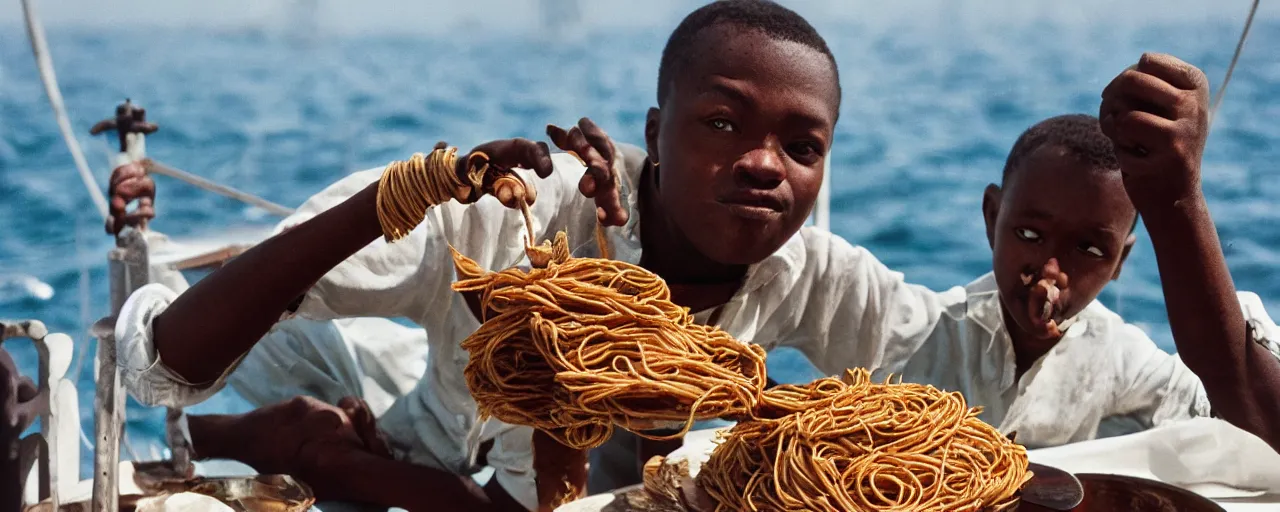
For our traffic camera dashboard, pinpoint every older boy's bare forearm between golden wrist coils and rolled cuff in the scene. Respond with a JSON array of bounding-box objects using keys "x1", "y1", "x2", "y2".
[{"x1": 152, "y1": 183, "x2": 381, "y2": 383}]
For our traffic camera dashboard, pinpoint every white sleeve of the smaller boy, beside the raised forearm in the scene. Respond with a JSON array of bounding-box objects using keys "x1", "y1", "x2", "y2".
[{"x1": 1112, "y1": 292, "x2": 1280, "y2": 426}]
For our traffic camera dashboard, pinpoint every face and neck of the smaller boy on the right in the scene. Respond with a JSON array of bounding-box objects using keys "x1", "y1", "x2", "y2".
[{"x1": 982, "y1": 146, "x2": 1137, "y2": 376}]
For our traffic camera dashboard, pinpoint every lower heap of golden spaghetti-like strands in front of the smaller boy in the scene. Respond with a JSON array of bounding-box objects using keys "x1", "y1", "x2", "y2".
[{"x1": 698, "y1": 370, "x2": 1030, "y2": 511}]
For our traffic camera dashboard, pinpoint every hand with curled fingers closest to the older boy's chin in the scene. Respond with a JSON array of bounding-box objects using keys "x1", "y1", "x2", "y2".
[{"x1": 547, "y1": 118, "x2": 628, "y2": 225}]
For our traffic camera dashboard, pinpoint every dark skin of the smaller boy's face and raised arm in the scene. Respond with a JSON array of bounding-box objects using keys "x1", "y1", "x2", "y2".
[{"x1": 983, "y1": 54, "x2": 1280, "y2": 451}]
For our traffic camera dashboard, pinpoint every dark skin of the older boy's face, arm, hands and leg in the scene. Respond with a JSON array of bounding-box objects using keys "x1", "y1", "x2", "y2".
[{"x1": 113, "y1": 26, "x2": 840, "y2": 511}]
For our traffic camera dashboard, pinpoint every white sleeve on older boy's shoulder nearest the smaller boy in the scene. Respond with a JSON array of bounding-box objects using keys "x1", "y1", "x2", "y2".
[{"x1": 788, "y1": 230, "x2": 945, "y2": 375}]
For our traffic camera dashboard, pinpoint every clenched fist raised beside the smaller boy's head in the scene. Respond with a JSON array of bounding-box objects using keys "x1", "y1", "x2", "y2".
[{"x1": 1098, "y1": 54, "x2": 1210, "y2": 214}]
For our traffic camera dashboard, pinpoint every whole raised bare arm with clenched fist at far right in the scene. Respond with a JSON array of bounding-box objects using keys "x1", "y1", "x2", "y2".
[{"x1": 1100, "y1": 54, "x2": 1280, "y2": 449}]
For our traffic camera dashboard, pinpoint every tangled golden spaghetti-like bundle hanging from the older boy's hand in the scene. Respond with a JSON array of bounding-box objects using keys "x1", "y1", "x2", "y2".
[{"x1": 453, "y1": 233, "x2": 764, "y2": 449}]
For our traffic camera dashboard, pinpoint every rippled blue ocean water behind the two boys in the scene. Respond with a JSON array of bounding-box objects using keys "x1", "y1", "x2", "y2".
[{"x1": 0, "y1": 18, "x2": 1280, "y2": 475}]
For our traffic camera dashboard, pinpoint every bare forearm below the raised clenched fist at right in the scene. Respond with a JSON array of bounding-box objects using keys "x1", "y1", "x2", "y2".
[{"x1": 1142, "y1": 195, "x2": 1280, "y2": 447}]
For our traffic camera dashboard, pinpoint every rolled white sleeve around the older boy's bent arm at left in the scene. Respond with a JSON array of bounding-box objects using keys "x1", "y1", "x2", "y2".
[{"x1": 116, "y1": 154, "x2": 594, "y2": 406}]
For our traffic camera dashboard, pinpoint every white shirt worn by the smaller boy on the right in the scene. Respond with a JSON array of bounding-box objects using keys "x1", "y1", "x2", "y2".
[{"x1": 874, "y1": 274, "x2": 1280, "y2": 448}]
